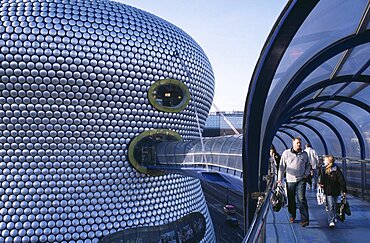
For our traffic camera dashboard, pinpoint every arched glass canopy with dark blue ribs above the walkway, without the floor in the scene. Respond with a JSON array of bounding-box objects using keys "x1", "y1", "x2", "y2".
[{"x1": 243, "y1": 0, "x2": 370, "y2": 227}]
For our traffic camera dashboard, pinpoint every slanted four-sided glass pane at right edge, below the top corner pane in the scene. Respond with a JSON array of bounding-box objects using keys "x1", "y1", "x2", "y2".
[{"x1": 338, "y1": 43, "x2": 370, "y2": 76}]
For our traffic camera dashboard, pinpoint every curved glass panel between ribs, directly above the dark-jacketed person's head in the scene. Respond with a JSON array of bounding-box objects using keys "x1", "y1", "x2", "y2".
[{"x1": 298, "y1": 117, "x2": 342, "y2": 156}]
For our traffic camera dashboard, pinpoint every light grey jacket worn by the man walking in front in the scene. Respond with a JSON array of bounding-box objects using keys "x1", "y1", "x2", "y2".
[{"x1": 278, "y1": 149, "x2": 311, "y2": 182}]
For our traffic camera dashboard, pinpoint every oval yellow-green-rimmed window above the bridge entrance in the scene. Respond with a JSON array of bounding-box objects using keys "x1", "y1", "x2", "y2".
[{"x1": 148, "y1": 79, "x2": 190, "y2": 112}]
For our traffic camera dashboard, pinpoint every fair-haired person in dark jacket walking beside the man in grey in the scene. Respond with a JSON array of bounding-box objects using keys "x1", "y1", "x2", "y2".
[{"x1": 319, "y1": 155, "x2": 347, "y2": 228}]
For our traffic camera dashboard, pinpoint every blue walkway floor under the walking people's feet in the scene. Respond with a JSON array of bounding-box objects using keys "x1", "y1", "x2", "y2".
[{"x1": 266, "y1": 191, "x2": 370, "y2": 243}]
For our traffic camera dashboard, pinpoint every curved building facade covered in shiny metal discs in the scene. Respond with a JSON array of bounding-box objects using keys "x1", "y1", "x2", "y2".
[{"x1": 0, "y1": 0, "x2": 214, "y2": 242}]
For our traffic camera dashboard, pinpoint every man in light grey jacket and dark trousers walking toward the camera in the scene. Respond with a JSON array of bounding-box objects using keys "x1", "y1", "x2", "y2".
[{"x1": 277, "y1": 137, "x2": 311, "y2": 227}]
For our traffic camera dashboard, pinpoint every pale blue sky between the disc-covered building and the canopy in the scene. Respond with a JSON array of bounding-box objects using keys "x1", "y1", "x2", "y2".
[{"x1": 119, "y1": 0, "x2": 287, "y2": 111}]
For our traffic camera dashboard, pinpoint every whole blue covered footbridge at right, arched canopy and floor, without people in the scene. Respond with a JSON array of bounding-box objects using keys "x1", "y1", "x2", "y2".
[{"x1": 243, "y1": 0, "x2": 370, "y2": 242}]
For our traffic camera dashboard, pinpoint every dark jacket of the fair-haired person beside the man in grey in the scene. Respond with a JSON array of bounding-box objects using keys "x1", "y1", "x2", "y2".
[{"x1": 319, "y1": 164, "x2": 347, "y2": 196}]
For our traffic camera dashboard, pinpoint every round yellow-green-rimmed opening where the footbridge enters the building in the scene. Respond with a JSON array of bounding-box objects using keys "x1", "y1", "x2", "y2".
[{"x1": 128, "y1": 129, "x2": 182, "y2": 175}]
